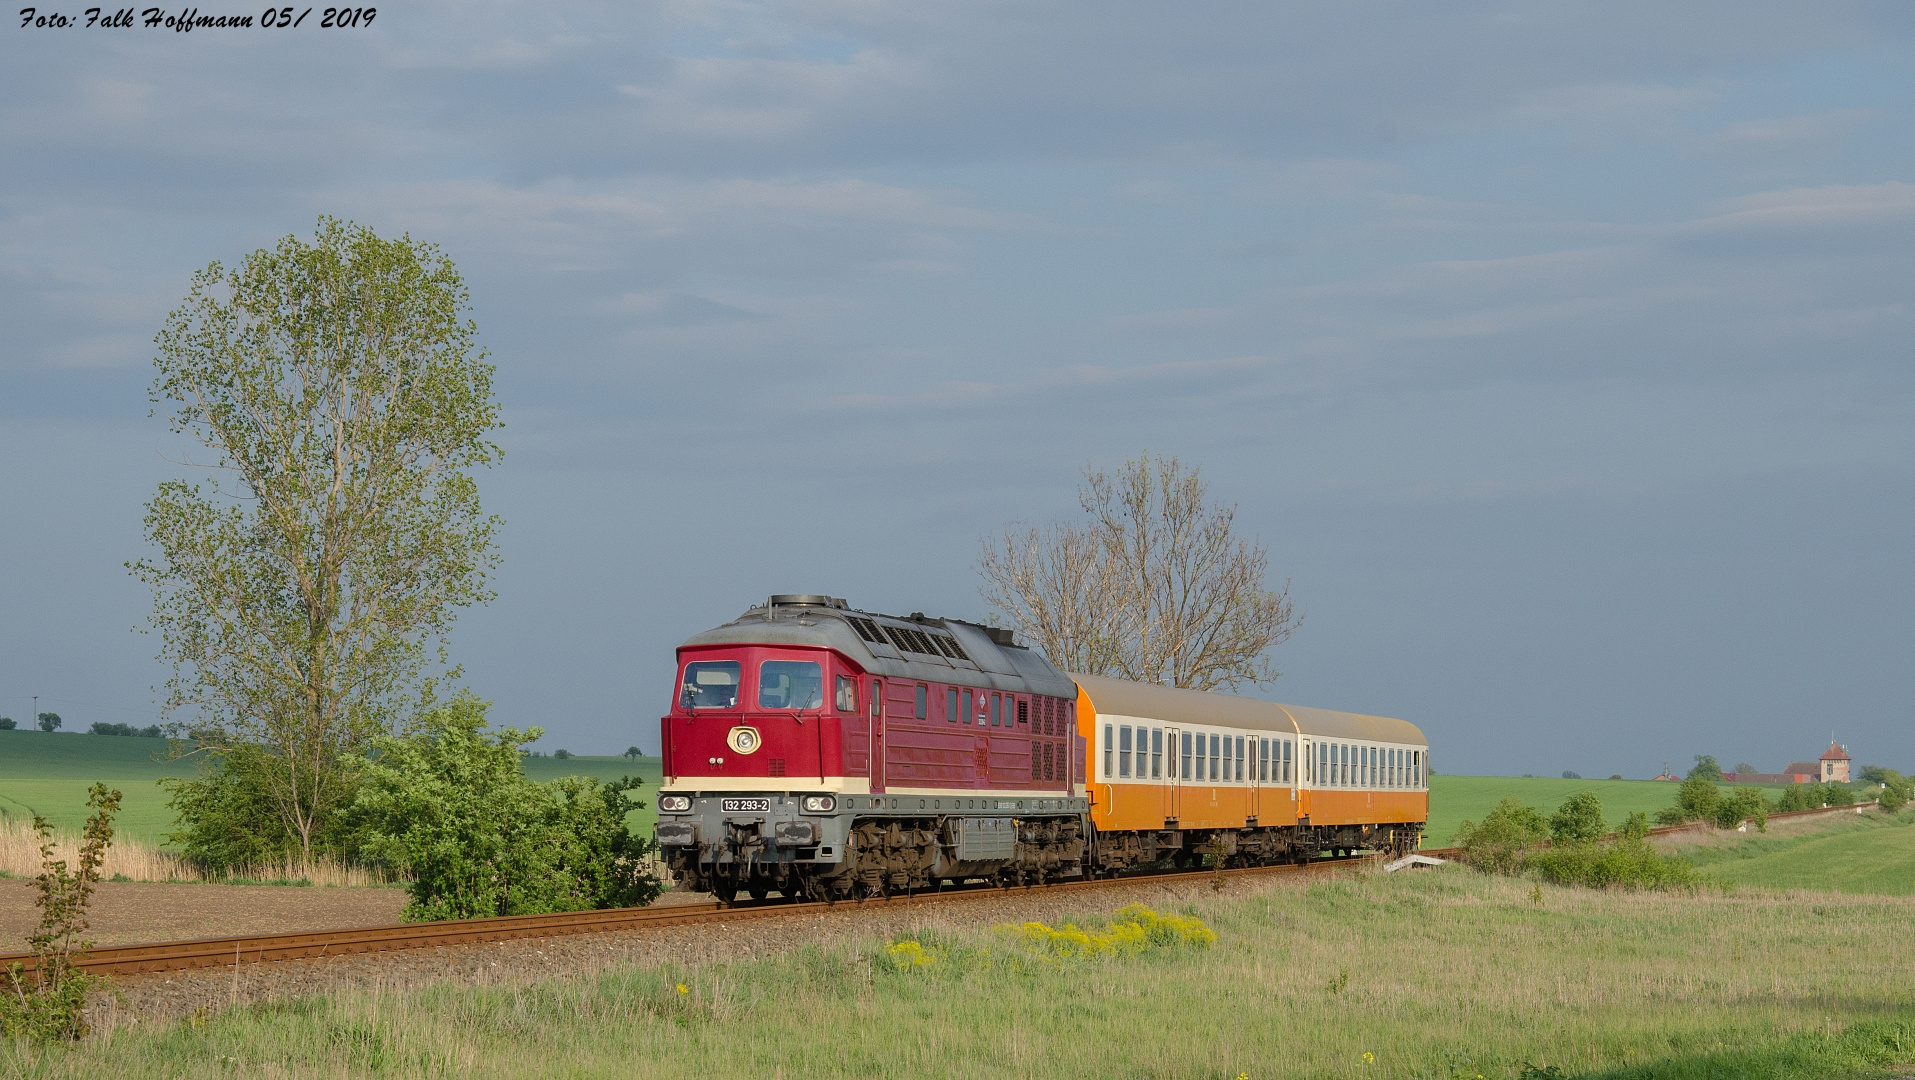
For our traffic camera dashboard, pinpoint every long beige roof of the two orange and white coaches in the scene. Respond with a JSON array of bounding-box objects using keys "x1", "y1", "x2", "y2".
[{"x1": 1070, "y1": 674, "x2": 1429, "y2": 747}]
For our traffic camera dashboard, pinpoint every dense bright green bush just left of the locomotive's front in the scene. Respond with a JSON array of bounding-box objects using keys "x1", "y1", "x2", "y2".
[{"x1": 356, "y1": 695, "x2": 659, "y2": 919}]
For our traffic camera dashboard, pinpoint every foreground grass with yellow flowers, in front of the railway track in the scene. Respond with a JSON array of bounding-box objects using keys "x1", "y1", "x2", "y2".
[{"x1": 0, "y1": 867, "x2": 1915, "y2": 1080}]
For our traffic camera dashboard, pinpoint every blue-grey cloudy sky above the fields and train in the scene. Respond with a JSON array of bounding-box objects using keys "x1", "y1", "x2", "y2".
[{"x1": 0, "y1": 2, "x2": 1915, "y2": 776}]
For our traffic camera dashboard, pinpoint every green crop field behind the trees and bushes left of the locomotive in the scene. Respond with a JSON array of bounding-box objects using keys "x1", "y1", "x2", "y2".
[{"x1": 0, "y1": 730, "x2": 659, "y2": 846}]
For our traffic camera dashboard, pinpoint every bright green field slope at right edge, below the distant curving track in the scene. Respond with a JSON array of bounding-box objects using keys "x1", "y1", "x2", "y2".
[{"x1": 1681, "y1": 810, "x2": 1915, "y2": 896}]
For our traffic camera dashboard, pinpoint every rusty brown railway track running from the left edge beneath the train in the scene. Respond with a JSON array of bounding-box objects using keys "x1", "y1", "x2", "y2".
[{"x1": 0, "y1": 856, "x2": 1373, "y2": 975}]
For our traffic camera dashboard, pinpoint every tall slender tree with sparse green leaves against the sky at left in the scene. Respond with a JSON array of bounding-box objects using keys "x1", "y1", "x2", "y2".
[{"x1": 128, "y1": 218, "x2": 500, "y2": 858}]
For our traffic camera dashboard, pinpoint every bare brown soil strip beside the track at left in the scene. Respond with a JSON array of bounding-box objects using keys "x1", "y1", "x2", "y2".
[{"x1": 0, "y1": 877, "x2": 406, "y2": 952}]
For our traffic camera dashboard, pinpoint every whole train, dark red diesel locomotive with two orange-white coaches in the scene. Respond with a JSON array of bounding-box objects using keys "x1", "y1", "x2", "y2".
[{"x1": 657, "y1": 594, "x2": 1429, "y2": 900}]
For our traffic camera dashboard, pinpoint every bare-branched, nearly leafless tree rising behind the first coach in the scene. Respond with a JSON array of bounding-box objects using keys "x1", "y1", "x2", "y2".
[{"x1": 979, "y1": 454, "x2": 1302, "y2": 689}]
